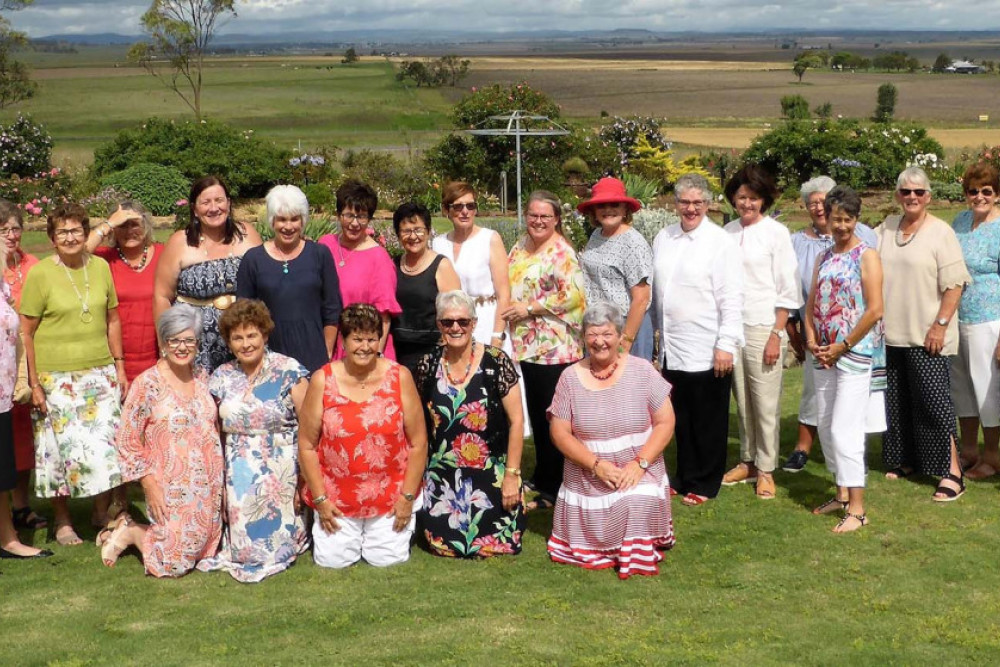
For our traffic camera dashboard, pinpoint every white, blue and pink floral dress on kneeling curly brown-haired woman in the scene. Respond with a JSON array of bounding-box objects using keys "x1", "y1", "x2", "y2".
[{"x1": 198, "y1": 351, "x2": 309, "y2": 583}]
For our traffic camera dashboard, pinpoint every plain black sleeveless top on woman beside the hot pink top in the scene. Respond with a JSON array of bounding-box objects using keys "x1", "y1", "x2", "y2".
[{"x1": 392, "y1": 255, "x2": 444, "y2": 377}]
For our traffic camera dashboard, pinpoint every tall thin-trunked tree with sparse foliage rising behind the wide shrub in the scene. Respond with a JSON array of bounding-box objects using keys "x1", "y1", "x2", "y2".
[{"x1": 128, "y1": 0, "x2": 236, "y2": 120}]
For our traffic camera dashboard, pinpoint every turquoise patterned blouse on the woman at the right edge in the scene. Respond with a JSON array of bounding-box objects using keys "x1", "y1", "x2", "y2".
[{"x1": 952, "y1": 210, "x2": 1000, "y2": 324}]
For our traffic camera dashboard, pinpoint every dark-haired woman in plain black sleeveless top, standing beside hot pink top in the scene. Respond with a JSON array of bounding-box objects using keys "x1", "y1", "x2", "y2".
[{"x1": 392, "y1": 202, "x2": 462, "y2": 377}]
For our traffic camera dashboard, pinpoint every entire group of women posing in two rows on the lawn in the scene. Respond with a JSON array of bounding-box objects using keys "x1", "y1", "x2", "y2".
[{"x1": 0, "y1": 157, "x2": 1000, "y2": 582}]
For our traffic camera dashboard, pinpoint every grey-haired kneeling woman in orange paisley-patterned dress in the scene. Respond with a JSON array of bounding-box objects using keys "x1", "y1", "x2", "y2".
[{"x1": 99, "y1": 304, "x2": 223, "y2": 577}]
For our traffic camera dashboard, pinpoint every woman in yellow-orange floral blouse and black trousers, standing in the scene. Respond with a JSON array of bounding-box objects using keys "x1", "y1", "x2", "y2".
[{"x1": 503, "y1": 190, "x2": 585, "y2": 511}]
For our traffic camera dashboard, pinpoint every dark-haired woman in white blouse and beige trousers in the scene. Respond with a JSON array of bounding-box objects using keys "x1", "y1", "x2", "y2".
[{"x1": 722, "y1": 165, "x2": 802, "y2": 500}]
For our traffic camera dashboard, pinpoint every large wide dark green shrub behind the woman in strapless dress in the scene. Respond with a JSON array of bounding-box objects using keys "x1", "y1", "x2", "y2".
[{"x1": 92, "y1": 118, "x2": 290, "y2": 197}]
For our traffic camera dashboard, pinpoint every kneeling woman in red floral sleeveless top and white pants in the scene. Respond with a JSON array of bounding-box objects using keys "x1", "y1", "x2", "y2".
[{"x1": 299, "y1": 303, "x2": 427, "y2": 568}]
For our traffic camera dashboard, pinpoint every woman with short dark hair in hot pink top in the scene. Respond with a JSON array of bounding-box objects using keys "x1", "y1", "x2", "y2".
[{"x1": 319, "y1": 180, "x2": 402, "y2": 360}]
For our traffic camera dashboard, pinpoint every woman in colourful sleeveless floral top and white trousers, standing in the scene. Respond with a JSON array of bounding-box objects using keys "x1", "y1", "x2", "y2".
[{"x1": 806, "y1": 187, "x2": 884, "y2": 533}]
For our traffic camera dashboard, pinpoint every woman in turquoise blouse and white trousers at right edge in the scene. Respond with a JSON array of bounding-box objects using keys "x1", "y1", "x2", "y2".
[{"x1": 951, "y1": 163, "x2": 1000, "y2": 479}]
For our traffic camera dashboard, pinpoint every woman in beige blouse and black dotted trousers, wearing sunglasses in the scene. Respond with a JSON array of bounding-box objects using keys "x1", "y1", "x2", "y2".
[{"x1": 875, "y1": 167, "x2": 972, "y2": 502}]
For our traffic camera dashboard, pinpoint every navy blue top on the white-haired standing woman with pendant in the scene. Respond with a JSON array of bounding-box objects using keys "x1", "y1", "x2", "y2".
[{"x1": 236, "y1": 241, "x2": 341, "y2": 373}]
